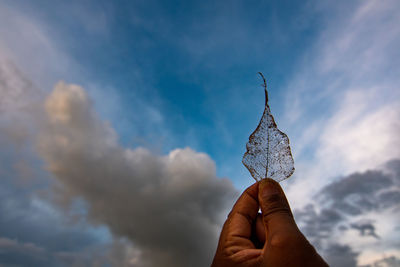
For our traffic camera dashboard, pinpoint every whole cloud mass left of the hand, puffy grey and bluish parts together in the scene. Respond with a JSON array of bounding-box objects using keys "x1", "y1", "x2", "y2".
[{"x1": 0, "y1": 54, "x2": 236, "y2": 266}]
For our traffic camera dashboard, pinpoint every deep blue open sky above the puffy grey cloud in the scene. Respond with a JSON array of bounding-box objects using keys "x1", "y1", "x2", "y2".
[{"x1": 0, "y1": 1, "x2": 328, "y2": 187}]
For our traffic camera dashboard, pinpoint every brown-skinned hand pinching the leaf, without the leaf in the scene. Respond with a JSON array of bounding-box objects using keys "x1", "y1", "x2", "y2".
[{"x1": 211, "y1": 179, "x2": 328, "y2": 267}]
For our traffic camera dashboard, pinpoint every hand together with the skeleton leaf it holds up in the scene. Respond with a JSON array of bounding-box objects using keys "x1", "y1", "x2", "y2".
[{"x1": 212, "y1": 73, "x2": 327, "y2": 267}]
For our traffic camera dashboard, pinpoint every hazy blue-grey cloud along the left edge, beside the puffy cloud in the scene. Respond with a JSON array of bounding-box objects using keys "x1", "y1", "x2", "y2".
[{"x1": 0, "y1": 60, "x2": 139, "y2": 267}]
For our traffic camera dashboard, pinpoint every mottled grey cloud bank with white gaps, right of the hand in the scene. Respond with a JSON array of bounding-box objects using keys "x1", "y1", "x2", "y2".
[{"x1": 294, "y1": 159, "x2": 400, "y2": 266}]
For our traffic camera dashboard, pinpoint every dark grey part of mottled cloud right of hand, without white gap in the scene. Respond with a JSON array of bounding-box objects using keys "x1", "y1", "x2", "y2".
[{"x1": 294, "y1": 160, "x2": 400, "y2": 266}]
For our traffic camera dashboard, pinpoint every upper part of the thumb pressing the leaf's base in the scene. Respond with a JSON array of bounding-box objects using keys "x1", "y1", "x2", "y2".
[{"x1": 258, "y1": 178, "x2": 297, "y2": 237}]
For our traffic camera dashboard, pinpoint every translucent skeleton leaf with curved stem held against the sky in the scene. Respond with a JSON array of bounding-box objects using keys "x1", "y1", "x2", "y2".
[{"x1": 242, "y1": 72, "x2": 294, "y2": 182}]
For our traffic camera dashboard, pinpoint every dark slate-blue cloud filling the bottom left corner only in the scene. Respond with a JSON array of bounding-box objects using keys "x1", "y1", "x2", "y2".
[{"x1": 0, "y1": 168, "x2": 114, "y2": 266}]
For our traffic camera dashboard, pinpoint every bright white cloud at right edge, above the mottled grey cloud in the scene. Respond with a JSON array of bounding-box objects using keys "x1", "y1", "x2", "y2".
[{"x1": 316, "y1": 90, "x2": 400, "y2": 175}]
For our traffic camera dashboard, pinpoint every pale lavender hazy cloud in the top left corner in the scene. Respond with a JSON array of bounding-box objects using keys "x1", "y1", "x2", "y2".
[{"x1": 0, "y1": 1, "x2": 77, "y2": 91}]
